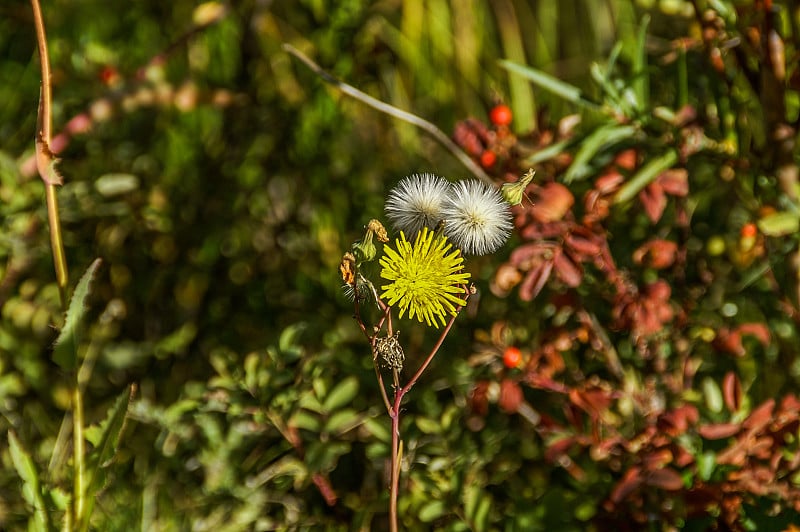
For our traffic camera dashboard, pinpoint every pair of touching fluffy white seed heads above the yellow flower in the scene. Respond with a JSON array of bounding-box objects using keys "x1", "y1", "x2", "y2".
[{"x1": 385, "y1": 173, "x2": 512, "y2": 255}]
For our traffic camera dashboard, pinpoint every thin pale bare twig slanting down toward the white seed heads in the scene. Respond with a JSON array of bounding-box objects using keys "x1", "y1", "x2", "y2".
[{"x1": 283, "y1": 43, "x2": 494, "y2": 186}]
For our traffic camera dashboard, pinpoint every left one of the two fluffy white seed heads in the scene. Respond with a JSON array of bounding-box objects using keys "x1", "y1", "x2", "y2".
[{"x1": 386, "y1": 174, "x2": 451, "y2": 237}]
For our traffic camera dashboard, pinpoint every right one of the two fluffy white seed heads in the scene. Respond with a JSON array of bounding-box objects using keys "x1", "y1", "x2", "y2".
[{"x1": 442, "y1": 179, "x2": 512, "y2": 255}]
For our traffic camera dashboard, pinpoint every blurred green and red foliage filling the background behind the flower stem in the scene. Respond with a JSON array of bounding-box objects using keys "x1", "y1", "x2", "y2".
[{"x1": 0, "y1": 0, "x2": 800, "y2": 531}]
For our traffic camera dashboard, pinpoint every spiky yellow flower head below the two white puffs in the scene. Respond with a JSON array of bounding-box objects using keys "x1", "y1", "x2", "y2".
[{"x1": 380, "y1": 227, "x2": 469, "y2": 328}]
